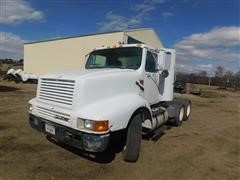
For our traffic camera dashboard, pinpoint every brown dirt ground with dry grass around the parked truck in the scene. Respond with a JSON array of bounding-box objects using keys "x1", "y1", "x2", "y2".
[{"x1": 0, "y1": 82, "x2": 240, "y2": 180}]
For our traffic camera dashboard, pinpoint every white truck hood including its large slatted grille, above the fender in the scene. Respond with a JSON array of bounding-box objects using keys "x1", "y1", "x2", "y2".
[{"x1": 37, "y1": 69, "x2": 140, "y2": 110}]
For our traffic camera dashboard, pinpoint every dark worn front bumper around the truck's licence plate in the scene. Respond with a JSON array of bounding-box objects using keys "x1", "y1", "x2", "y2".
[{"x1": 29, "y1": 114, "x2": 110, "y2": 152}]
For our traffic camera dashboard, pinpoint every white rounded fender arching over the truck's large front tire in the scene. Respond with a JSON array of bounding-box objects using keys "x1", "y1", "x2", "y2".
[{"x1": 78, "y1": 93, "x2": 150, "y2": 131}]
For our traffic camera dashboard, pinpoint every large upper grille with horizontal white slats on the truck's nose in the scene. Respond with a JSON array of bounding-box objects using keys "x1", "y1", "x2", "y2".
[{"x1": 39, "y1": 78, "x2": 75, "y2": 105}]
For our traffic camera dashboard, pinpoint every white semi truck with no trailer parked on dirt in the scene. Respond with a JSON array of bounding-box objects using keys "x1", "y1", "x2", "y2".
[{"x1": 28, "y1": 44, "x2": 191, "y2": 162}]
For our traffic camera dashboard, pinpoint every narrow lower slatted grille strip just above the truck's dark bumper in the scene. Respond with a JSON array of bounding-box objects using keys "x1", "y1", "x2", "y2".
[{"x1": 37, "y1": 106, "x2": 70, "y2": 122}]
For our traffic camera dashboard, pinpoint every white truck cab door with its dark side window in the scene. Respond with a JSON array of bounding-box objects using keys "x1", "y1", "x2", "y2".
[{"x1": 144, "y1": 51, "x2": 160, "y2": 104}]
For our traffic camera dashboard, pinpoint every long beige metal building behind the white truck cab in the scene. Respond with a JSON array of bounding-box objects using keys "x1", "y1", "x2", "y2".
[{"x1": 24, "y1": 28, "x2": 163, "y2": 75}]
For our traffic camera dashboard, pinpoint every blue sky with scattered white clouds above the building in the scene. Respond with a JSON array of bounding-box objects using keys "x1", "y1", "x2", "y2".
[{"x1": 0, "y1": 0, "x2": 240, "y2": 75}]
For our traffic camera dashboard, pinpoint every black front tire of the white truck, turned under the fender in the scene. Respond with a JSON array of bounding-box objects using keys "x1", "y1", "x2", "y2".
[{"x1": 123, "y1": 114, "x2": 142, "y2": 162}]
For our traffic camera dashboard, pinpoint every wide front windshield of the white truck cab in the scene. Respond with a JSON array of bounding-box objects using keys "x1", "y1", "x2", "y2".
[{"x1": 86, "y1": 47, "x2": 142, "y2": 69}]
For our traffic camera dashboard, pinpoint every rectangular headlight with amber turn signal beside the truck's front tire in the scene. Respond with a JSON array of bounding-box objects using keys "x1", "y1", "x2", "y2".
[{"x1": 77, "y1": 118, "x2": 109, "y2": 132}]
